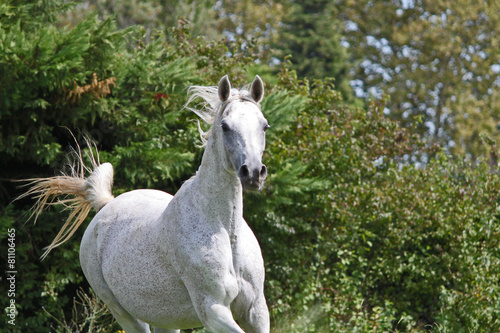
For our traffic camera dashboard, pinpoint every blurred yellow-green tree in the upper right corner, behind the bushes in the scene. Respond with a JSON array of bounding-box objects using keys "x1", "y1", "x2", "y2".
[{"x1": 342, "y1": 0, "x2": 500, "y2": 157}]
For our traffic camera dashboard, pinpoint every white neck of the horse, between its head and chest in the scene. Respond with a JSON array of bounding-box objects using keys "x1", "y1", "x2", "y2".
[{"x1": 193, "y1": 137, "x2": 243, "y2": 234}]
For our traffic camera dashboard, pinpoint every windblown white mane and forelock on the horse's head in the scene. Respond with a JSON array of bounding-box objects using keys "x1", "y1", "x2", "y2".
[{"x1": 184, "y1": 86, "x2": 260, "y2": 147}]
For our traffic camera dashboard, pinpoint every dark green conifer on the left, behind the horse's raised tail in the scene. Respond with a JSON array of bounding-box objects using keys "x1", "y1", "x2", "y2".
[{"x1": 0, "y1": 0, "x2": 197, "y2": 326}]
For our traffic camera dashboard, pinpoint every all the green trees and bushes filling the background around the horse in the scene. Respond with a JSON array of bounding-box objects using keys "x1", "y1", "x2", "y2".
[{"x1": 0, "y1": 0, "x2": 500, "y2": 332}]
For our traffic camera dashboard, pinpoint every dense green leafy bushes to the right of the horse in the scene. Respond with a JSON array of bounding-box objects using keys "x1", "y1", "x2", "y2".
[{"x1": 245, "y1": 64, "x2": 500, "y2": 332}]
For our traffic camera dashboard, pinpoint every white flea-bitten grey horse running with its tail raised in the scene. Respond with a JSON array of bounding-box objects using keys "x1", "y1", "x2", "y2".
[{"x1": 27, "y1": 76, "x2": 269, "y2": 333}]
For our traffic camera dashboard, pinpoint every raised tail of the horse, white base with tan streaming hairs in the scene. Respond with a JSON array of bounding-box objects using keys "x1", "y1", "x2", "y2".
[{"x1": 18, "y1": 154, "x2": 114, "y2": 260}]
